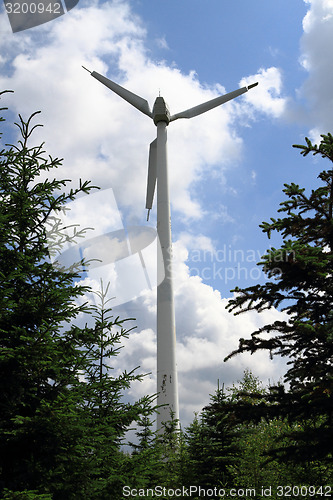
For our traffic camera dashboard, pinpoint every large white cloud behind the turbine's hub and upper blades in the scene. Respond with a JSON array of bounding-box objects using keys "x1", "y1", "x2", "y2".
[{"x1": 0, "y1": 1, "x2": 282, "y2": 219}]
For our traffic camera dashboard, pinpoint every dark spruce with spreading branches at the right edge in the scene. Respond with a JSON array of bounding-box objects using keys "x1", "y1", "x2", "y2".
[{"x1": 226, "y1": 134, "x2": 333, "y2": 461}]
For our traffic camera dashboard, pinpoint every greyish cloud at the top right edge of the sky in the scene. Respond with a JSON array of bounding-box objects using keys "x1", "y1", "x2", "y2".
[{"x1": 300, "y1": 0, "x2": 333, "y2": 139}]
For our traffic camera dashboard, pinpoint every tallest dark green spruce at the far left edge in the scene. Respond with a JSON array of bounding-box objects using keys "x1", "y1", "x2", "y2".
[{"x1": 0, "y1": 96, "x2": 91, "y2": 489}]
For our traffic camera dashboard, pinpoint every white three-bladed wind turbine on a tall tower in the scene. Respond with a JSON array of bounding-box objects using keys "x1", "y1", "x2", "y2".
[{"x1": 83, "y1": 66, "x2": 258, "y2": 432}]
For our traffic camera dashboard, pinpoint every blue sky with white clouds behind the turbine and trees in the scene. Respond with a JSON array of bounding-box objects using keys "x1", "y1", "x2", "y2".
[{"x1": 0, "y1": 0, "x2": 333, "y2": 424}]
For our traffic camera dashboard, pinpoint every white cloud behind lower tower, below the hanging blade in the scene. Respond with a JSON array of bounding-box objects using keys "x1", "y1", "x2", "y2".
[{"x1": 112, "y1": 234, "x2": 286, "y2": 424}]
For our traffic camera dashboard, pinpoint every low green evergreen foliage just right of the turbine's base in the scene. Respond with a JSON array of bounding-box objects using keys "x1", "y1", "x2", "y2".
[{"x1": 186, "y1": 370, "x2": 333, "y2": 500}]
